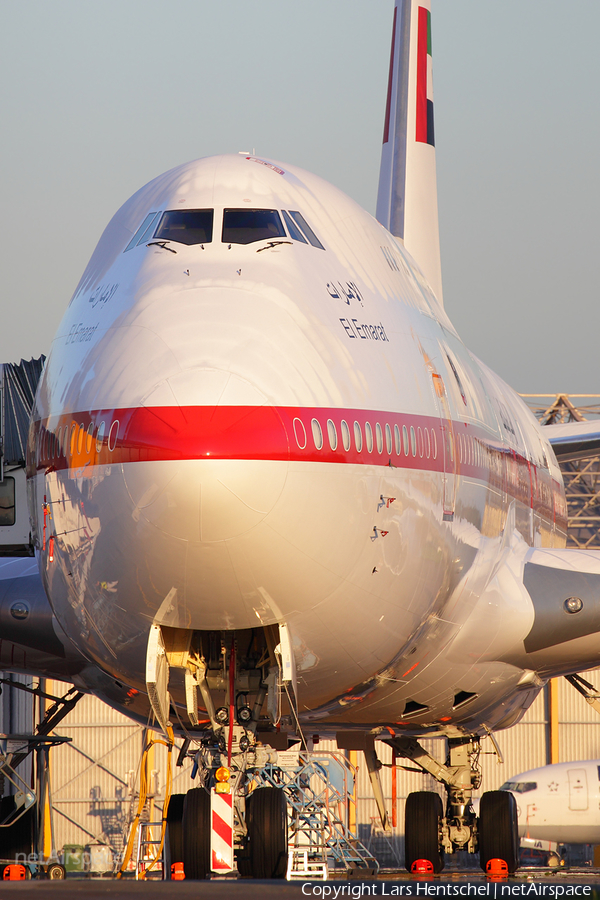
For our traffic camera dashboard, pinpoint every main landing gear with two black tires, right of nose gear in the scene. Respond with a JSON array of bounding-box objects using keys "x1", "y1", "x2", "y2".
[{"x1": 390, "y1": 736, "x2": 519, "y2": 872}]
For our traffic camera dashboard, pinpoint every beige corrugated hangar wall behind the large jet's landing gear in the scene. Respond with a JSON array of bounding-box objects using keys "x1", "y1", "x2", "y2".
[{"x1": 39, "y1": 669, "x2": 600, "y2": 865}]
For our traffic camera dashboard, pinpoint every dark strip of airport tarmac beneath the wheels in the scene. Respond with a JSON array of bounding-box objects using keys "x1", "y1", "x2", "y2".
[{"x1": 0, "y1": 868, "x2": 600, "y2": 900}]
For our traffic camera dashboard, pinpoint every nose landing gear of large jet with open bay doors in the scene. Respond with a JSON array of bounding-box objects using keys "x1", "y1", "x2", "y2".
[{"x1": 146, "y1": 625, "x2": 296, "y2": 880}]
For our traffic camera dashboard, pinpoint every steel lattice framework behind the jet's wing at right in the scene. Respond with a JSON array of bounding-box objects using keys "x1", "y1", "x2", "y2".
[{"x1": 521, "y1": 394, "x2": 600, "y2": 550}]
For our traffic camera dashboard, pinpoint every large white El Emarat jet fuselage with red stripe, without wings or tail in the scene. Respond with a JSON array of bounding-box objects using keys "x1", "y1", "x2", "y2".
[{"x1": 28, "y1": 155, "x2": 566, "y2": 731}]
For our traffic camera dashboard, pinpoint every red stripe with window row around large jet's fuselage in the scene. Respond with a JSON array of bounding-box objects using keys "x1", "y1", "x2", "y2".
[{"x1": 28, "y1": 406, "x2": 564, "y2": 520}]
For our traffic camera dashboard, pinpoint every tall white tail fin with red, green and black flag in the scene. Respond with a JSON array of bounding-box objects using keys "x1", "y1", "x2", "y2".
[{"x1": 377, "y1": 0, "x2": 442, "y2": 303}]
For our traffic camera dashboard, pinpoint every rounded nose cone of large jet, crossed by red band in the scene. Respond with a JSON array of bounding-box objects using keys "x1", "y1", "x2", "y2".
[{"x1": 124, "y1": 367, "x2": 287, "y2": 544}]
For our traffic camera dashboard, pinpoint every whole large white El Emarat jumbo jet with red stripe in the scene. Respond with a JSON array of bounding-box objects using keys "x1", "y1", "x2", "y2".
[{"x1": 0, "y1": 0, "x2": 600, "y2": 877}]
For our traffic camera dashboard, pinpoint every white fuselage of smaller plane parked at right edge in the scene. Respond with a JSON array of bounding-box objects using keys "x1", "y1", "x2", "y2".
[{"x1": 503, "y1": 759, "x2": 600, "y2": 844}]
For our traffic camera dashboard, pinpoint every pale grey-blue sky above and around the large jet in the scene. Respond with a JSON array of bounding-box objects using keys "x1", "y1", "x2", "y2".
[{"x1": 0, "y1": 0, "x2": 600, "y2": 393}]
